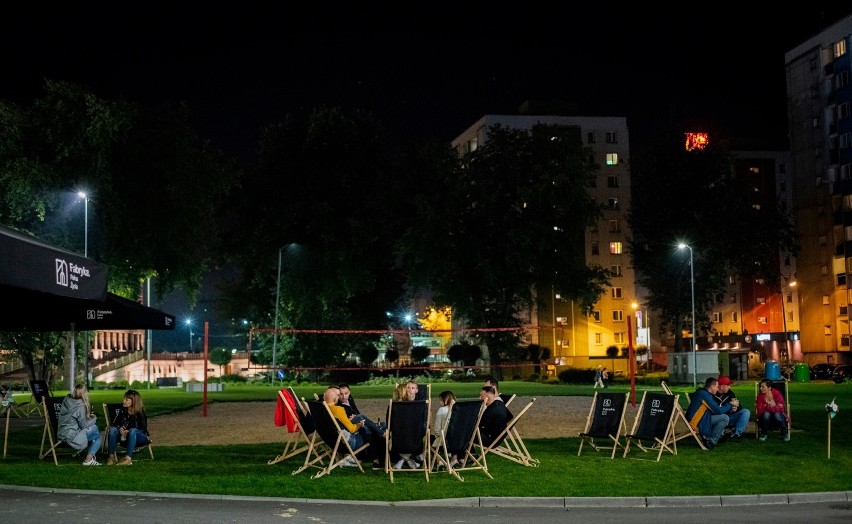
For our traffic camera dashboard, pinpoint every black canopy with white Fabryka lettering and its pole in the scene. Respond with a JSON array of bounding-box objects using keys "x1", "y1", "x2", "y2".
[{"x1": 0, "y1": 226, "x2": 175, "y2": 383}]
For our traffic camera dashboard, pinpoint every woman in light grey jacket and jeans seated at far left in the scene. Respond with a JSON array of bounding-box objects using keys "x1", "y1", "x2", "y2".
[{"x1": 56, "y1": 384, "x2": 102, "y2": 466}]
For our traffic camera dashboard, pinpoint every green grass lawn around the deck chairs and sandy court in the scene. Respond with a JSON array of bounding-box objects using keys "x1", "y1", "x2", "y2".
[{"x1": 6, "y1": 382, "x2": 852, "y2": 501}]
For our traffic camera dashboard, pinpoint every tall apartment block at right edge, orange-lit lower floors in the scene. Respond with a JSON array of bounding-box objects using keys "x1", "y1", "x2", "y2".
[{"x1": 785, "y1": 12, "x2": 852, "y2": 364}]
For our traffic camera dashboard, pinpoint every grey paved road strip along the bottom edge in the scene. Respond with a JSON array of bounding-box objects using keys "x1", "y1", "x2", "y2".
[{"x1": 0, "y1": 487, "x2": 852, "y2": 524}]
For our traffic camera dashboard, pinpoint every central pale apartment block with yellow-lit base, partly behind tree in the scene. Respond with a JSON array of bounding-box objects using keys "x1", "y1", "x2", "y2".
[{"x1": 452, "y1": 104, "x2": 638, "y2": 367}]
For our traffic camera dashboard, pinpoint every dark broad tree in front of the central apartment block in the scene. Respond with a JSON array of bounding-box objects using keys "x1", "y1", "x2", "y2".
[{"x1": 399, "y1": 126, "x2": 608, "y2": 364}]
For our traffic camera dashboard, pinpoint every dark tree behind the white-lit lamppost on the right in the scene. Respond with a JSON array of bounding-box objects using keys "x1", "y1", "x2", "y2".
[{"x1": 628, "y1": 131, "x2": 796, "y2": 351}]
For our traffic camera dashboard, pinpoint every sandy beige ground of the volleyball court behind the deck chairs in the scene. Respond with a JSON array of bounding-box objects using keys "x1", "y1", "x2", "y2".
[{"x1": 148, "y1": 397, "x2": 638, "y2": 446}]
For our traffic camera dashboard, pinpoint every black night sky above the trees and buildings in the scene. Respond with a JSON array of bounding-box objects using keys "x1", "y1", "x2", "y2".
[{"x1": 0, "y1": 6, "x2": 852, "y2": 346}]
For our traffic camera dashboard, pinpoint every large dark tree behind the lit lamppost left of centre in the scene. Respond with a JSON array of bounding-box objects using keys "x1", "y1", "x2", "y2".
[{"x1": 222, "y1": 108, "x2": 408, "y2": 366}]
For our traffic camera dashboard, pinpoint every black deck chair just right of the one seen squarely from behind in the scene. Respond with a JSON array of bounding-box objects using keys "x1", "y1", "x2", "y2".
[{"x1": 429, "y1": 399, "x2": 494, "y2": 482}]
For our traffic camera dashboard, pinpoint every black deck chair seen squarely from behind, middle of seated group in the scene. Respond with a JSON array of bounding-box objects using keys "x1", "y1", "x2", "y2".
[{"x1": 385, "y1": 398, "x2": 432, "y2": 482}]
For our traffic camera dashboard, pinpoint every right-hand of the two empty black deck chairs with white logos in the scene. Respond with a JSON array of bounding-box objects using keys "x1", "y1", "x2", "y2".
[{"x1": 622, "y1": 391, "x2": 678, "y2": 462}]
